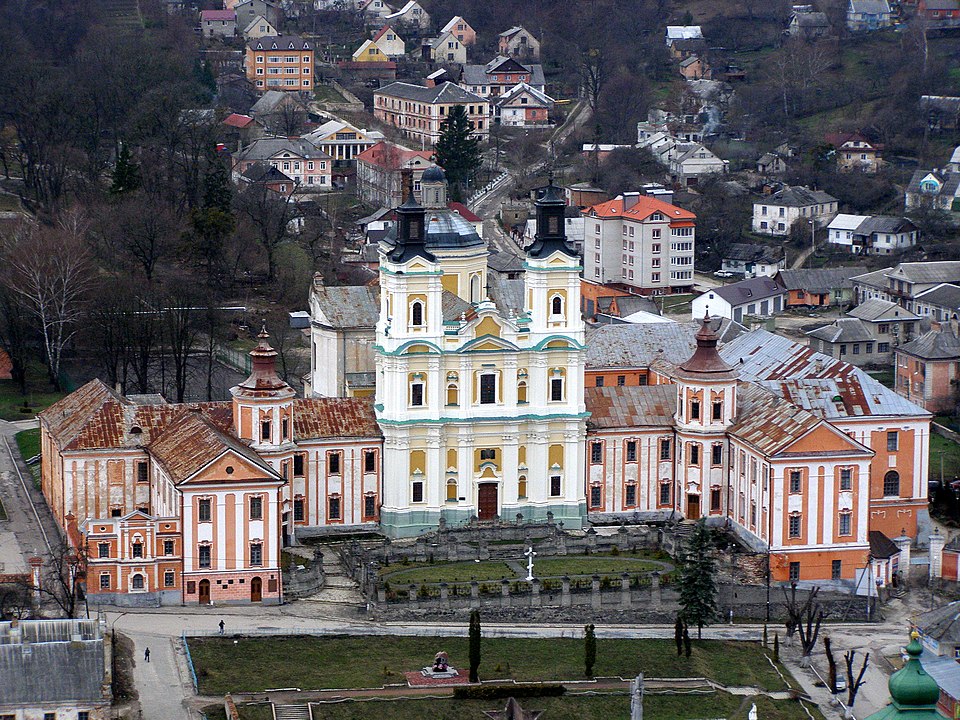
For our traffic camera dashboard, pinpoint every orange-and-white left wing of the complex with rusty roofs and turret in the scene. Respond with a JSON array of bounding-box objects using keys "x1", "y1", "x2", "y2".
[{"x1": 40, "y1": 340, "x2": 382, "y2": 607}]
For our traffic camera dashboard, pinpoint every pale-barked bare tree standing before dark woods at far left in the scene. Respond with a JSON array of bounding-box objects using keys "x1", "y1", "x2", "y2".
[{"x1": 3, "y1": 210, "x2": 93, "y2": 390}]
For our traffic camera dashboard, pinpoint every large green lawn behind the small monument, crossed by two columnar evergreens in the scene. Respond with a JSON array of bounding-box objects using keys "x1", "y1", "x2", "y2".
[{"x1": 190, "y1": 636, "x2": 784, "y2": 695}]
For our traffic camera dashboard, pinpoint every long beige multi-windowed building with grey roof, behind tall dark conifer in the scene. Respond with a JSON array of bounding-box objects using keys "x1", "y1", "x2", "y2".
[{"x1": 373, "y1": 82, "x2": 490, "y2": 145}]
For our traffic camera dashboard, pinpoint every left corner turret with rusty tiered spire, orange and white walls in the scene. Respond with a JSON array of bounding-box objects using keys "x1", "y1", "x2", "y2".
[{"x1": 230, "y1": 327, "x2": 296, "y2": 450}]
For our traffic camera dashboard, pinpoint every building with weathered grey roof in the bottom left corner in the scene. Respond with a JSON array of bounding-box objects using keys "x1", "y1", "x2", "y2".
[{"x1": 0, "y1": 614, "x2": 111, "y2": 720}]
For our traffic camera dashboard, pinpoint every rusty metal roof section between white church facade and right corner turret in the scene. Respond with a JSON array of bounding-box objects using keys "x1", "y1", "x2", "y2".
[{"x1": 584, "y1": 385, "x2": 677, "y2": 429}]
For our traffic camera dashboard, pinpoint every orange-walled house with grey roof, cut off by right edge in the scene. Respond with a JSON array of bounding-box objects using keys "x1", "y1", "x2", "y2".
[{"x1": 895, "y1": 319, "x2": 960, "y2": 415}]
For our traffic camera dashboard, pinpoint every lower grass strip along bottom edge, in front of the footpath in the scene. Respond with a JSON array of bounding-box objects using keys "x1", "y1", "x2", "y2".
[{"x1": 204, "y1": 692, "x2": 823, "y2": 720}]
